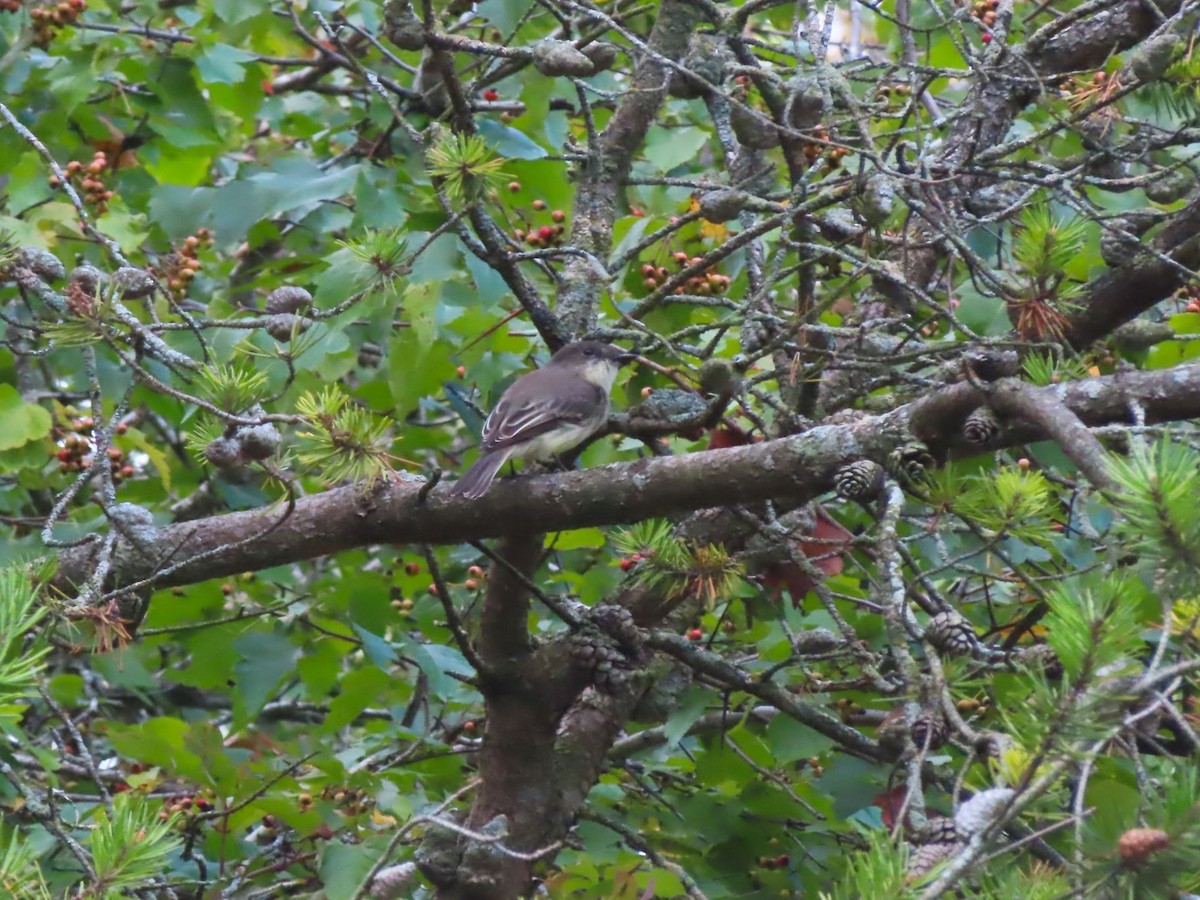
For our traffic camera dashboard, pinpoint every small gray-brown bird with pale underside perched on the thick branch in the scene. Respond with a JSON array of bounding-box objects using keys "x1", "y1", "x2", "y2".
[{"x1": 454, "y1": 341, "x2": 637, "y2": 498}]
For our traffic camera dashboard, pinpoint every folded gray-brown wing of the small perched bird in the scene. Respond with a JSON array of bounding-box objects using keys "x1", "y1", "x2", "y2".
[{"x1": 480, "y1": 370, "x2": 607, "y2": 452}]
